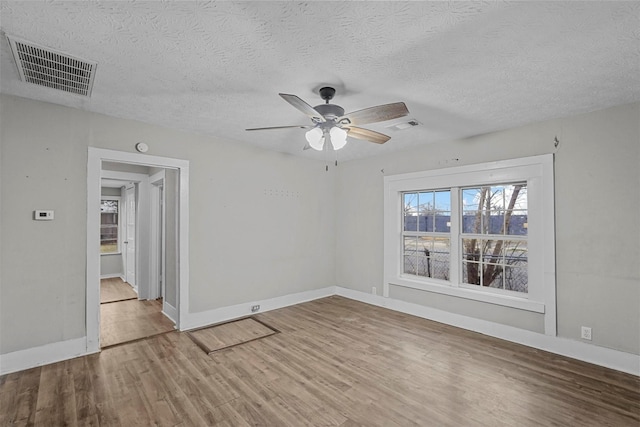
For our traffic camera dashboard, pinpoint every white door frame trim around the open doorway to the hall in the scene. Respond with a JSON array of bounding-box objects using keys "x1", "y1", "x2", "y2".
[{"x1": 85, "y1": 147, "x2": 189, "y2": 353}]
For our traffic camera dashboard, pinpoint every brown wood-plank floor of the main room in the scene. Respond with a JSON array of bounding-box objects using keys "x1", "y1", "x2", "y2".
[{"x1": 0, "y1": 296, "x2": 640, "y2": 427}]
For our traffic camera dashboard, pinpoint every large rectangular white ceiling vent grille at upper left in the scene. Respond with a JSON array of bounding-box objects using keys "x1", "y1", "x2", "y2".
[{"x1": 7, "y1": 35, "x2": 97, "y2": 97}]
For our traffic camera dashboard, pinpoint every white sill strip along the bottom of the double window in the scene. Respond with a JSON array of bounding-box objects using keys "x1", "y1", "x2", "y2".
[{"x1": 386, "y1": 277, "x2": 545, "y2": 313}]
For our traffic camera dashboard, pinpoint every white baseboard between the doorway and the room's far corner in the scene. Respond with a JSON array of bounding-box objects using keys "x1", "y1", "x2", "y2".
[{"x1": 180, "y1": 286, "x2": 336, "y2": 331}]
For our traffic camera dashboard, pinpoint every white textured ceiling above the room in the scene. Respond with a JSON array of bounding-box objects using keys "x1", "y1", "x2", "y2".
[{"x1": 0, "y1": 1, "x2": 640, "y2": 160}]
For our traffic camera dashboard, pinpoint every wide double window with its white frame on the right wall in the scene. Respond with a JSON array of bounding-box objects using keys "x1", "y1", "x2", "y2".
[{"x1": 383, "y1": 155, "x2": 555, "y2": 333}]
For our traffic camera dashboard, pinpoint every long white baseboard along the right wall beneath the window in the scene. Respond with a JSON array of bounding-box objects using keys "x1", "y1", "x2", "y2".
[{"x1": 336, "y1": 286, "x2": 640, "y2": 376}]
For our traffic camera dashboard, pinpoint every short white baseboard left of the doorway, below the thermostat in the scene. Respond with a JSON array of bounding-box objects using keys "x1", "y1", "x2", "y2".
[{"x1": 0, "y1": 337, "x2": 89, "y2": 375}]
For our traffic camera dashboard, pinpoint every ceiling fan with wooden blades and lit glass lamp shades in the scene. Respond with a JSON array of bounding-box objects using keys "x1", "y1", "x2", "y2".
[{"x1": 246, "y1": 86, "x2": 409, "y2": 151}]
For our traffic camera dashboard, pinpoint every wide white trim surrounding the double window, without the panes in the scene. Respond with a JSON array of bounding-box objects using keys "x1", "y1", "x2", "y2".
[{"x1": 383, "y1": 154, "x2": 556, "y2": 335}]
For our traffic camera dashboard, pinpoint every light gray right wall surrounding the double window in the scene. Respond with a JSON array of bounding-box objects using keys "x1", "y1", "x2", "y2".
[{"x1": 336, "y1": 104, "x2": 640, "y2": 354}]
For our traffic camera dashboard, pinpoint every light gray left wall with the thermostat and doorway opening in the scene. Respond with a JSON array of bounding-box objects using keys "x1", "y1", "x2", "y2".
[{"x1": 0, "y1": 95, "x2": 335, "y2": 354}]
